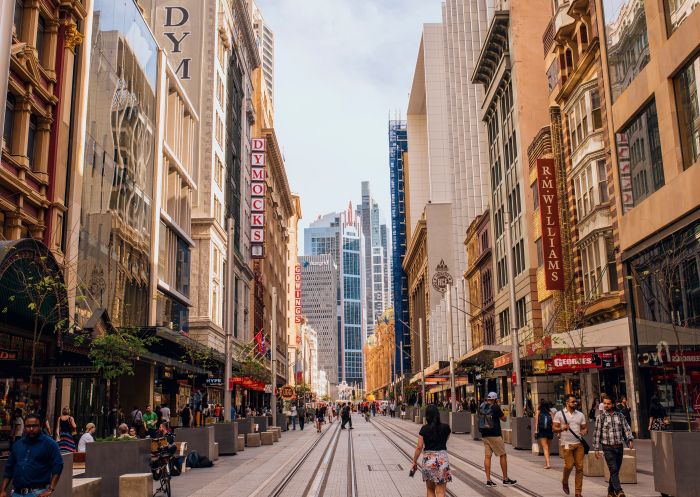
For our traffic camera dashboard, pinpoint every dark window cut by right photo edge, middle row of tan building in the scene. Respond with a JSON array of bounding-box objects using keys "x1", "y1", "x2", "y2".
[{"x1": 673, "y1": 54, "x2": 700, "y2": 169}]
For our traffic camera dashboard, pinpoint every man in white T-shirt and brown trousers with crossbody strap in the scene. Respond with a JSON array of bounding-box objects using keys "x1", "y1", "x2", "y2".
[{"x1": 554, "y1": 394, "x2": 588, "y2": 497}]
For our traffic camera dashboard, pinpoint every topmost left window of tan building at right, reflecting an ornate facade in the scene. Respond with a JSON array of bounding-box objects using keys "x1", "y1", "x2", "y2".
[{"x1": 603, "y1": 0, "x2": 649, "y2": 101}]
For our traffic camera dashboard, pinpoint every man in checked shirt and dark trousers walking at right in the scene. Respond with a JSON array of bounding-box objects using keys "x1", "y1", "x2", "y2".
[{"x1": 593, "y1": 397, "x2": 634, "y2": 497}]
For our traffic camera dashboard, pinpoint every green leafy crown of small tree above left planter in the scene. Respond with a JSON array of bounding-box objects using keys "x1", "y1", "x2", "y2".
[{"x1": 76, "y1": 328, "x2": 158, "y2": 380}]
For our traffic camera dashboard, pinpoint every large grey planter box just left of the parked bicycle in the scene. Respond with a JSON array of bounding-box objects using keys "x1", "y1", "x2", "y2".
[{"x1": 85, "y1": 438, "x2": 150, "y2": 497}]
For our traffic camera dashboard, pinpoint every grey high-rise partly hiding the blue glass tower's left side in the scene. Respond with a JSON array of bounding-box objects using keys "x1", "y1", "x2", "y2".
[{"x1": 299, "y1": 254, "x2": 339, "y2": 398}]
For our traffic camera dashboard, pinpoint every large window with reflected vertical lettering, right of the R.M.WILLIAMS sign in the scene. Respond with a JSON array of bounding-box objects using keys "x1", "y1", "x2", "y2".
[{"x1": 615, "y1": 101, "x2": 664, "y2": 212}]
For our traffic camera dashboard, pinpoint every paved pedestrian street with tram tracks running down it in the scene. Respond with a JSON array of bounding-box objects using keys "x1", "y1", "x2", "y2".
[{"x1": 167, "y1": 415, "x2": 658, "y2": 497}]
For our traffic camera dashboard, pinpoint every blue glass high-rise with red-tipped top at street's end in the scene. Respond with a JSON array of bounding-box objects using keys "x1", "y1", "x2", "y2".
[{"x1": 304, "y1": 207, "x2": 366, "y2": 386}]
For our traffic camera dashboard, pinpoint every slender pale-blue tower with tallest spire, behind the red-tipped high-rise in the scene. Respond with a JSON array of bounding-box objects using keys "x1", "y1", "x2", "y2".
[{"x1": 356, "y1": 181, "x2": 391, "y2": 336}]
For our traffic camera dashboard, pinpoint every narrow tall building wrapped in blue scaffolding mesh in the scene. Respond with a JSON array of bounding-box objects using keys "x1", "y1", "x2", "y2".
[{"x1": 388, "y1": 120, "x2": 412, "y2": 373}]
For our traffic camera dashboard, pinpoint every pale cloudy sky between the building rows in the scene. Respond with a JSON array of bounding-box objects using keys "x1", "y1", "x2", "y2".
[{"x1": 256, "y1": 0, "x2": 441, "y2": 254}]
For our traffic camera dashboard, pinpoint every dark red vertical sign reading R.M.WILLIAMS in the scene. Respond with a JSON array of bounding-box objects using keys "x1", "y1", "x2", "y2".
[{"x1": 537, "y1": 159, "x2": 564, "y2": 290}]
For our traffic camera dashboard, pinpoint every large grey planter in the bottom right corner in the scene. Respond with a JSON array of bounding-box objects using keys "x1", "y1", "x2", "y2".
[{"x1": 651, "y1": 431, "x2": 700, "y2": 497}]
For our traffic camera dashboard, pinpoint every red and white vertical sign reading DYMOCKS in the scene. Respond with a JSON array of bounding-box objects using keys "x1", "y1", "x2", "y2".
[{"x1": 250, "y1": 138, "x2": 266, "y2": 259}]
